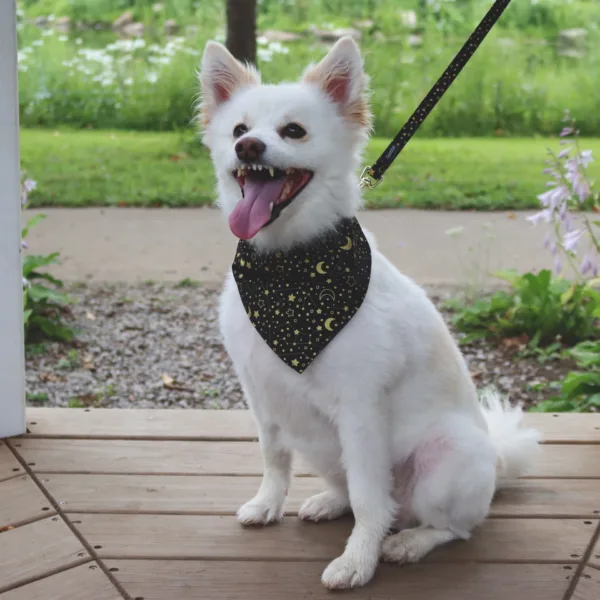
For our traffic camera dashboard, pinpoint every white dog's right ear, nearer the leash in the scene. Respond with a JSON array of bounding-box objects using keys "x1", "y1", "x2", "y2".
[{"x1": 302, "y1": 37, "x2": 371, "y2": 128}]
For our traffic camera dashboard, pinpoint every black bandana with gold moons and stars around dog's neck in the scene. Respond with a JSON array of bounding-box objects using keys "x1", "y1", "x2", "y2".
[{"x1": 232, "y1": 219, "x2": 371, "y2": 373}]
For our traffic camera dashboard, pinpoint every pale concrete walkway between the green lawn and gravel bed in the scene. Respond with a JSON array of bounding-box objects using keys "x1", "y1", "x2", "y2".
[{"x1": 22, "y1": 208, "x2": 564, "y2": 286}]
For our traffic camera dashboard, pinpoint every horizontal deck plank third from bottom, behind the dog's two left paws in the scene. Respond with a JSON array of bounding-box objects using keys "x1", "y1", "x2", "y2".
[{"x1": 44, "y1": 473, "x2": 600, "y2": 518}]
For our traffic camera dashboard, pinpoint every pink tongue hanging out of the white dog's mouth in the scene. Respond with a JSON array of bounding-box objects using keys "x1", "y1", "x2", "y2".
[{"x1": 229, "y1": 177, "x2": 285, "y2": 240}]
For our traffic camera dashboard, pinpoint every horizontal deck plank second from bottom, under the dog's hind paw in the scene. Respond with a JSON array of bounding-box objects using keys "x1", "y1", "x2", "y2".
[{"x1": 76, "y1": 514, "x2": 595, "y2": 563}]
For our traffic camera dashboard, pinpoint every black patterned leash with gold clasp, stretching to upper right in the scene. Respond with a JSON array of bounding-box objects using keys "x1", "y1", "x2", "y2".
[{"x1": 360, "y1": 0, "x2": 510, "y2": 189}]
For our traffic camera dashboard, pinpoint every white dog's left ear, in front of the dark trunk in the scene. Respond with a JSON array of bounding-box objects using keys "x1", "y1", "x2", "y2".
[{"x1": 199, "y1": 42, "x2": 260, "y2": 126}]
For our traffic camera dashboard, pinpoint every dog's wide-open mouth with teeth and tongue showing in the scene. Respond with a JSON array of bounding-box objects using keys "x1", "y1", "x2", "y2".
[{"x1": 229, "y1": 164, "x2": 313, "y2": 240}]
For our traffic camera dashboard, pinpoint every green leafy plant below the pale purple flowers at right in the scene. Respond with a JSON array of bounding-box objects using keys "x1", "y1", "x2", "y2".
[{"x1": 453, "y1": 269, "x2": 600, "y2": 348}]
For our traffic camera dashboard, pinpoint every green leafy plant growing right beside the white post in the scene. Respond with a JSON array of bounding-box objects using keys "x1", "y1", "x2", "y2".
[{"x1": 21, "y1": 179, "x2": 73, "y2": 343}]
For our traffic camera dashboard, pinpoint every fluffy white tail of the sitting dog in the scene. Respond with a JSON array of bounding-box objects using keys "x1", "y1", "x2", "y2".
[{"x1": 481, "y1": 389, "x2": 541, "y2": 489}]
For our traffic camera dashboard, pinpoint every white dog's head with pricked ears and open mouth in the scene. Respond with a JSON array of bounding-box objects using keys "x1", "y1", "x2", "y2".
[{"x1": 200, "y1": 38, "x2": 371, "y2": 249}]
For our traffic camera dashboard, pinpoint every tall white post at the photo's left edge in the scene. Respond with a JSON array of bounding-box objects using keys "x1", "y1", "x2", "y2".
[{"x1": 0, "y1": 0, "x2": 25, "y2": 438}]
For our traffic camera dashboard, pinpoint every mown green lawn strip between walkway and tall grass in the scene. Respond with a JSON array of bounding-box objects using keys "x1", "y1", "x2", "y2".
[{"x1": 21, "y1": 129, "x2": 600, "y2": 210}]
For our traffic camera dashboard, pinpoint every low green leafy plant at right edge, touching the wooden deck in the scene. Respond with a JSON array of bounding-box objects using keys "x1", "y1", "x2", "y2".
[{"x1": 532, "y1": 340, "x2": 600, "y2": 412}]
